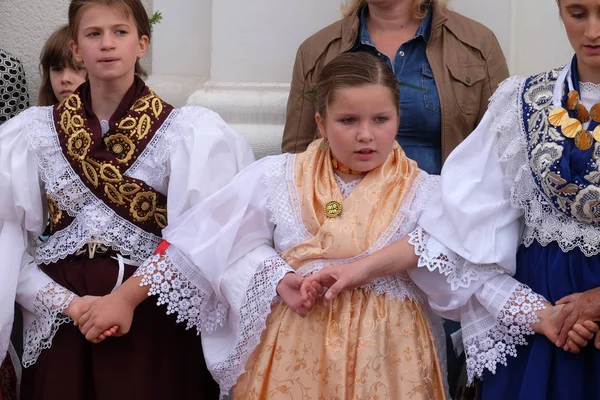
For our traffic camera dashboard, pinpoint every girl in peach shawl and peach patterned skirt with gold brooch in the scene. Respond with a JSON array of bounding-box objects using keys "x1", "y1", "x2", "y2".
[{"x1": 79, "y1": 53, "x2": 446, "y2": 399}]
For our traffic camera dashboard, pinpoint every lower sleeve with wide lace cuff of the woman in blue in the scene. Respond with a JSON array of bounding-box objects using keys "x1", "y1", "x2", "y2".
[{"x1": 410, "y1": 227, "x2": 545, "y2": 382}]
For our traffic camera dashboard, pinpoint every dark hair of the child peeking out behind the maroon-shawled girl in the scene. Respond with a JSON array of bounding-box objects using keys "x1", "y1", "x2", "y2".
[{"x1": 38, "y1": 25, "x2": 82, "y2": 106}]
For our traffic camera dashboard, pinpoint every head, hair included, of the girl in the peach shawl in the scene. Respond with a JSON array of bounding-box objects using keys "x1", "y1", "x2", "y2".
[{"x1": 315, "y1": 53, "x2": 400, "y2": 172}]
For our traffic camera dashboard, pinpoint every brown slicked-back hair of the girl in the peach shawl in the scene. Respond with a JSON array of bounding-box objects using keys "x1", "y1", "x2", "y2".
[{"x1": 315, "y1": 52, "x2": 400, "y2": 117}]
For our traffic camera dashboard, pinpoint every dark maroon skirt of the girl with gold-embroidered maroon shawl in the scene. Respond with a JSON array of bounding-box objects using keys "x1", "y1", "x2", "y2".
[{"x1": 21, "y1": 254, "x2": 219, "y2": 400}]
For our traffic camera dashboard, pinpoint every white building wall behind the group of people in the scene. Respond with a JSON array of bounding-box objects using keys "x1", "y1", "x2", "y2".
[{"x1": 0, "y1": 0, "x2": 572, "y2": 154}]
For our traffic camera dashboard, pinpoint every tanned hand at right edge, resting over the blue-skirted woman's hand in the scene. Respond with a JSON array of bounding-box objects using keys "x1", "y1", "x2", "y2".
[{"x1": 556, "y1": 288, "x2": 600, "y2": 347}]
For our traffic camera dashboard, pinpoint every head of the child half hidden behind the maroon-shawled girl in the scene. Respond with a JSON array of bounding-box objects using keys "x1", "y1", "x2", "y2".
[{"x1": 38, "y1": 25, "x2": 85, "y2": 106}]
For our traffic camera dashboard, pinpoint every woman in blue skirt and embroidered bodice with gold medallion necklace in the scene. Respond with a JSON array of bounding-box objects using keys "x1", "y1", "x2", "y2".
[{"x1": 296, "y1": 0, "x2": 600, "y2": 400}]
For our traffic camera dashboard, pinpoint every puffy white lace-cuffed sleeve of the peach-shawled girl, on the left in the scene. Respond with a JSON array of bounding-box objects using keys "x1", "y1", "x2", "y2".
[{"x1": 136, "y1": 155, "x2": 293, "y2": 394}]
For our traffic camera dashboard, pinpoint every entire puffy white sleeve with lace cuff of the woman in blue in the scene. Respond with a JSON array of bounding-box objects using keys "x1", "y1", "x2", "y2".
[{"x1": 409, "y1": 78, "x2": 544, "y2": 381}]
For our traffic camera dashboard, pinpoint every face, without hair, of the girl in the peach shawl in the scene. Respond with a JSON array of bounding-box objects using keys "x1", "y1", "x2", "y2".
[{"x1": 316, "y1": 85, "x2": 399, "y2": 172}]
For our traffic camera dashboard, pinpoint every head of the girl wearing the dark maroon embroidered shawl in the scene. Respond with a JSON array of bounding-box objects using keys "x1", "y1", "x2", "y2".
[{"x1": 69, "y1": 0, "x2": 151, "y2": 81}]
